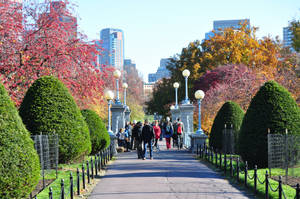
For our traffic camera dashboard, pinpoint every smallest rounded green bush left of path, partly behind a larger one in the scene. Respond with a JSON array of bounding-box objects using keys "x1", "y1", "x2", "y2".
[{"x1": 81, "y1": 109, "x2": 110, "y2": 154}]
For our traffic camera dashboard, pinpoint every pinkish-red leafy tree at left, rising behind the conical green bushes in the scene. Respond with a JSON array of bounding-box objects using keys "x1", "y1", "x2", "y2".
[{"x1": 0, "y1": 0, "x2": 105, "y2": 108}]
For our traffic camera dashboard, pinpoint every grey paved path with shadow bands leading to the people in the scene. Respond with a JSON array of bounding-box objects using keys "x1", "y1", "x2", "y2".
[{"x1": 89, "y1": 142, "x2": 254, "y2": 199}]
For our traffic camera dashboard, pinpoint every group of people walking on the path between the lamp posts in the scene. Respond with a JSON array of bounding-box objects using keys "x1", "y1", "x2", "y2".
[{"x1": 117, "y1": 117, "x2": 184, "y2": 160}]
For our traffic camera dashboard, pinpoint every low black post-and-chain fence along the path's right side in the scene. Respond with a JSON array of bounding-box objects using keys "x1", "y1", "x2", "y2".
[{"x1": 197, "y1": 145, "x2": 300, "y2": 199}]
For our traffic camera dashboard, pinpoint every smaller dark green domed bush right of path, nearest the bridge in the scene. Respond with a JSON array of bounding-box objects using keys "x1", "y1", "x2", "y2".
[{"x1": 209, "y1": 101, "x2": 244, "y2": 151}]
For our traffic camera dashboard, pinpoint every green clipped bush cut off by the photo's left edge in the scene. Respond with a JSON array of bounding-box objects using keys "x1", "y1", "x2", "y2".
[{"x1": 0, "y1": 84, "x2": 40, "y2": 198}]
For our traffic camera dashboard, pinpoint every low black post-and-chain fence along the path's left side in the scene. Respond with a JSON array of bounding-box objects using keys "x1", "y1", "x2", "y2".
[{"x1": 34, "y1": 145, "x2": 113, "y2": 199}]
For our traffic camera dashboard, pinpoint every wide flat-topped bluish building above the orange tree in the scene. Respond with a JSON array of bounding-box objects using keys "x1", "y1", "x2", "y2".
[{"x1": 204, "y1": 19, "x2": 250, "y2": 40}]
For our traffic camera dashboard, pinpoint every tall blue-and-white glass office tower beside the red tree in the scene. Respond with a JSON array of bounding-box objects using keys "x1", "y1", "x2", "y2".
[{"x1": 99, "y1": 28, "x2": 124, "y2": 70}]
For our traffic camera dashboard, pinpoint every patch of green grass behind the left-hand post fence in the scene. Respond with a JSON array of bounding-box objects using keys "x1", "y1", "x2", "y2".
[{"x1": 37, "y1": 156, "x2": 110, "y2": 199}]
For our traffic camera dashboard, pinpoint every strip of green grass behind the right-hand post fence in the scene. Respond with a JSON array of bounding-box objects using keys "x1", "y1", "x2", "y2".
[{"x1": 202, "y1": 152, "x2": 296, "y2": 199}]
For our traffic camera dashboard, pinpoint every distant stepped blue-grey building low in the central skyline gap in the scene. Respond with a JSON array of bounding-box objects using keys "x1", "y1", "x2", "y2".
[{"x1": 148, "y1": 58, "x2": 171, "y2": 83}]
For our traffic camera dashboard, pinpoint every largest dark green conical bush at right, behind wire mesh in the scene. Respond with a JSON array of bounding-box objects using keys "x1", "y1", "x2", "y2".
[{"x1": 238, "y1": 81, "x2": 300, "y2": 168}]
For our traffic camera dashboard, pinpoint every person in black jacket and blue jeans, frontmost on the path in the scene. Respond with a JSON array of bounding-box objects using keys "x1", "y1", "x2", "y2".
[{"x1": 142, "y1": 119, "x2": 154, "y2": 160}]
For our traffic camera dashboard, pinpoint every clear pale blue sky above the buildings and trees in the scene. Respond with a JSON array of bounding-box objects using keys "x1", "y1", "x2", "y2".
[{"x1": 72, "y1": 0, "x2": 300, "y2": 81}]
